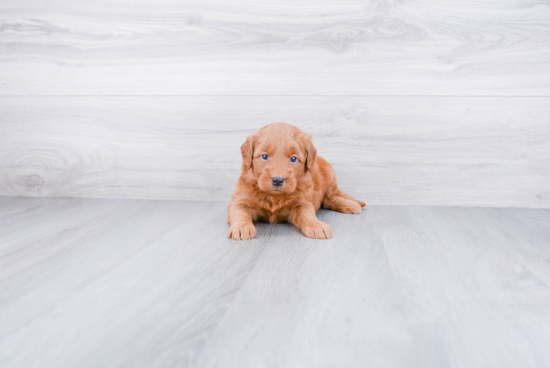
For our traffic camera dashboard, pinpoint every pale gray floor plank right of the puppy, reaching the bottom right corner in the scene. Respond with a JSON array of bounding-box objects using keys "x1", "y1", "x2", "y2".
[{"x1": 372, "y1": 207, "x2": 550, "y2": 367}]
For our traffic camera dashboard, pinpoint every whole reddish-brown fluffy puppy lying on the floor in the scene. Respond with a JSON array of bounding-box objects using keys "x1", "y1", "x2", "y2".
[{"x1": 227, "y1": 123, "x2": 365, "y2": 240}]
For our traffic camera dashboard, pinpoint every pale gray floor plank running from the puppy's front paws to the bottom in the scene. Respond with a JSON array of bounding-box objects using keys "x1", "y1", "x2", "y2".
[{"x1": 196, "y1": 209, "x2": 429, "y2": 368}]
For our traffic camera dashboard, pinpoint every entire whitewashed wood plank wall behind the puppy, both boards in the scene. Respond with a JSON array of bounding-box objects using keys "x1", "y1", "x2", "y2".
[{"x1": 0, "y1": 0, "x2": 550, "y2": 207}]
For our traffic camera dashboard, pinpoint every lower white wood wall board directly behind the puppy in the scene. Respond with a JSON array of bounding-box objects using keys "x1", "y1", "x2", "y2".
[{"x1": 0, "y1": 96, "x2": 550, "y2": 208}]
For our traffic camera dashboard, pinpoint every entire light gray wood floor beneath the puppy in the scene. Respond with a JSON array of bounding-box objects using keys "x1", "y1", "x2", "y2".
[{"x1": 0, "y1": 197, "x2": 550, "y2": 368}]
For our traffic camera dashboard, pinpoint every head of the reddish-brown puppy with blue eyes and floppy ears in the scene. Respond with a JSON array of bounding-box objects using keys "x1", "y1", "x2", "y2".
[{"x1": 241, "y1": 123, "x2": 317, "y2": 195}]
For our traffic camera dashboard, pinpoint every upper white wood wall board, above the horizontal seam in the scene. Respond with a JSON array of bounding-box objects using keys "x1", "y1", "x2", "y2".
[{"x1": 0, "y1": 0, "x2": 550, "y2": 96}]
